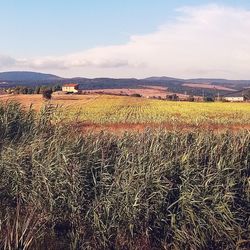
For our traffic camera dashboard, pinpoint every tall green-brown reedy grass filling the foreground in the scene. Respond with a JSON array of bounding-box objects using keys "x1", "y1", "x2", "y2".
[{"x1": 0, "y1": 103, "x2": 250, "y2": 249}]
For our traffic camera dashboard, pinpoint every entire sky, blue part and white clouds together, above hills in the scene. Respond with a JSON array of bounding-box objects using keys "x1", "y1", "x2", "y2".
[{"x1": 0, "y1": 0, "x2": 250, "y2": 79}]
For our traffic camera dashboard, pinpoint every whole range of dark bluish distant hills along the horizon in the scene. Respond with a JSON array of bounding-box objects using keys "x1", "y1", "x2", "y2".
[{"x1": 0, "y1": 71, "x2": 250, "y2": 96}]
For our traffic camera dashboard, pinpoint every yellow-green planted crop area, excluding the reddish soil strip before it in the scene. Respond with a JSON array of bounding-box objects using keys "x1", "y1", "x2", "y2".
[{"x1": 66, "y1": 96, "x2": 250, "y2": 125}]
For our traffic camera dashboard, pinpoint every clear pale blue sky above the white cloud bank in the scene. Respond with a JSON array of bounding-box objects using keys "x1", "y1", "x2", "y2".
[{"x1": 0, "y1": 0, "x2": 250, "y2": 56}]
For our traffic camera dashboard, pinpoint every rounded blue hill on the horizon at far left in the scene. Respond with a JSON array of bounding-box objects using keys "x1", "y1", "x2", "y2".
[{"x1": 0, "y1": 71, "x2": 61, "y2": 82}]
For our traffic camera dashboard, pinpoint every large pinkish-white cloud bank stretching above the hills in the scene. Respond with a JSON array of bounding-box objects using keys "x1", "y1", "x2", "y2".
[{"x1": 0, "y1": 5, "x2": 250, "y2": 79}]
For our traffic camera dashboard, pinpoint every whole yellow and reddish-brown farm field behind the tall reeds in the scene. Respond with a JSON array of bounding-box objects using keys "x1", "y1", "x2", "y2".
[{"x1": 0, "y1": 95, "x2": 250, "y2": 131}]
